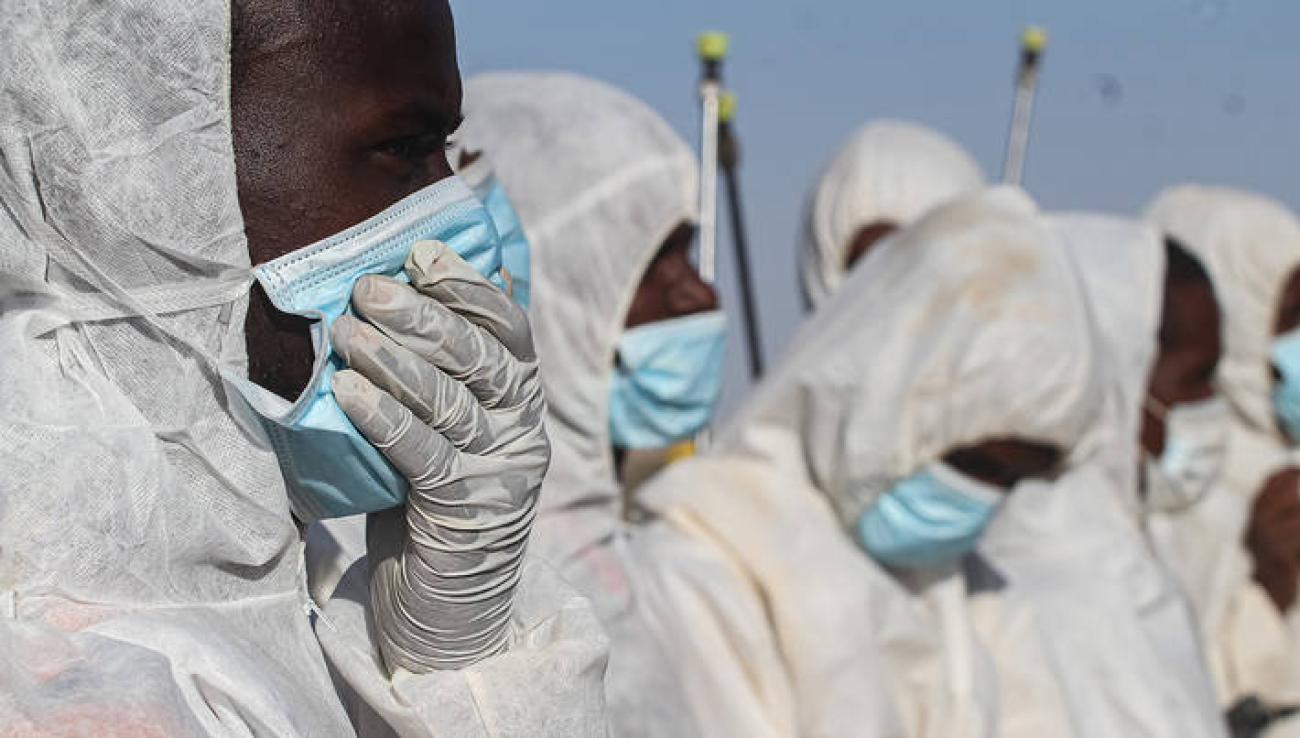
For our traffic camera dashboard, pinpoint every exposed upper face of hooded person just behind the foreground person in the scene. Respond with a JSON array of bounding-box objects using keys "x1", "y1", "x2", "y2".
[{"x1": 623, "y1": 223, "x2": 718, "y2": 327}]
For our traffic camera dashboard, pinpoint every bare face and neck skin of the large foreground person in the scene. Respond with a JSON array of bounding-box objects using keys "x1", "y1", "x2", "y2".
[{"x1": 231, "y1": 0, "x2": 462, "y2": 399}]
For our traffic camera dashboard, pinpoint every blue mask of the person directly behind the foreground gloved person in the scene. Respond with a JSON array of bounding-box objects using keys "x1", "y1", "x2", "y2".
[{"x1": 610, "y1": 311, "x2": 727, "y2": 448}]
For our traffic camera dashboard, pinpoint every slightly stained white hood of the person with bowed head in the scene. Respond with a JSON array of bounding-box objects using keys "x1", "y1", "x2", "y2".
[{"x1": 754, "y1": 188, "x2": 1097, "y2": 525}]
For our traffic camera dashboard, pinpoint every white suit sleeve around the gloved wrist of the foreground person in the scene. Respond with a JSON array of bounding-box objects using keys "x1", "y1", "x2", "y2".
[{"x1": 316, "y1": 557, "x2": 608, "y2": 738}]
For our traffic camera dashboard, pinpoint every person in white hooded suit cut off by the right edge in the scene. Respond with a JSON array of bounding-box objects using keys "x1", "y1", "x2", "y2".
[{"x1": 1148, "y1": 185, "x2": 1300, "y2": 735}]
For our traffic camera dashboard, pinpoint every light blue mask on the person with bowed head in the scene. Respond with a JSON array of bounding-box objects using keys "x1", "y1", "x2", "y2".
[{"x1": 858, "y1": 463, "x2": 1005, "y2": 568}]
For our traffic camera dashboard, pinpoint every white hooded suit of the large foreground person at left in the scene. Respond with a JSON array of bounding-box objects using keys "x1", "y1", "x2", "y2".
[{"x1": 0, "y1": 0, "x2": 603, "y2": 737}]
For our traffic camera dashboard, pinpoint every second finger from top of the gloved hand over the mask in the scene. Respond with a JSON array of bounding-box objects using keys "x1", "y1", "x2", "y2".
[{"x1": 353, "y1": 277, "x2": 525, "y2": 409}]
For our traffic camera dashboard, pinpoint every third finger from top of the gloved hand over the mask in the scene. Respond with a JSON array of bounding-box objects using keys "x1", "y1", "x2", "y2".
[{"x1": 330, "y1": 316, "x2": 491, "y2": 452}]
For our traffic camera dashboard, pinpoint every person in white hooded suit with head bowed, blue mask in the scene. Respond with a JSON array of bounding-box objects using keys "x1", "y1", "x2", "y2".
[{"x1": 633, "y1": 188, "x2": 1222, "y2": 738}]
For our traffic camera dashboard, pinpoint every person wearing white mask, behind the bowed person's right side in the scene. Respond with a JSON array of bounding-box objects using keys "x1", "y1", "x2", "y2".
[{"x1": 969, "y1": 213, "x2": 1225, "y2": 738}]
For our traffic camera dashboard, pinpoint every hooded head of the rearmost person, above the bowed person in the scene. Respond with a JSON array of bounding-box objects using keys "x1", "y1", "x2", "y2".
[{"x1": 800, "y1": 121, "x2": 984, "y2": 309}]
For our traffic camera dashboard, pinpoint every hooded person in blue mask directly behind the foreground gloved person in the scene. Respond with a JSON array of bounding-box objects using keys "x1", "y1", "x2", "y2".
[{"x1": 458, "y1": 73, "x2": 725, "y2": 737}]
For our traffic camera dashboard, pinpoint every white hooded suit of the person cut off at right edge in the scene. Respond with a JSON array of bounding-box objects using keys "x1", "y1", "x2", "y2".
[{"x1": 1147, "y1": 185, "x2": 1300, "y2": 717}]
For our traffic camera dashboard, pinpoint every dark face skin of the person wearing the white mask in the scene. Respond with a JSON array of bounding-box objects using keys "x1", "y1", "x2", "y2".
[{"x1": 1140, "y1": 281, "x2": 1223, "y2": 456}]
